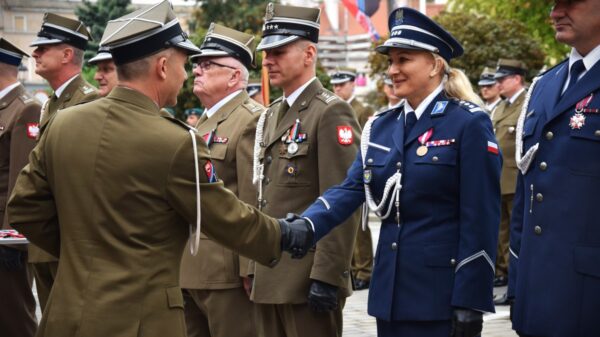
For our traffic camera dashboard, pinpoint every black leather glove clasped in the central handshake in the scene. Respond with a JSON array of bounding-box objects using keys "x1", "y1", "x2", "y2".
[{"x1": 277, "y1": 213, "x2": 314, "y2": 259}]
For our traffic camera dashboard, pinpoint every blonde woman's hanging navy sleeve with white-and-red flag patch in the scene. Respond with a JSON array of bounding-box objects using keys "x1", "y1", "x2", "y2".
[{"x1": 451, "y1": 113, "x2": 502, "y2": 312}]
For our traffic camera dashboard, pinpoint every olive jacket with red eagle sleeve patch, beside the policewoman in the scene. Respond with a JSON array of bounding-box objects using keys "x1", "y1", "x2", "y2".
[{"x1": 251, "y1": 80, "x2": 360, "y2": 304}]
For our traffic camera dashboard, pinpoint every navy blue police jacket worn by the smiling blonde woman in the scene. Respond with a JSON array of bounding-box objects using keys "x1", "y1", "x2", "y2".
[{"x1": 302, "y1": 92, "x2": 502, "y2": 321}]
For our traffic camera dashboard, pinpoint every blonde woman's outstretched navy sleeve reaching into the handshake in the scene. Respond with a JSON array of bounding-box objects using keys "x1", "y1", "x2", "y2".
[{"x1": 301, "y1": 151, "x2": 365, "y2": 242}]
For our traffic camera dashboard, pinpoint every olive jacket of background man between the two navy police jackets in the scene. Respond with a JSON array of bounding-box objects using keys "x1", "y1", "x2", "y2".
[{"x1": 492, "y1": 90, "x2": 527, "y2": 195}]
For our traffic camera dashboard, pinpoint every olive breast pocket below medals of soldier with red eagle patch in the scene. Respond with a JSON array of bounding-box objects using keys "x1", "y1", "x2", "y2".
[{"x1": 277, "y1": 142, "x2": 318, "y2": 187}]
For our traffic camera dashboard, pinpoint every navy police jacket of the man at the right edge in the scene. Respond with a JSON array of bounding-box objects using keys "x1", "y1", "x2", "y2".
[{"x1": 508, "y1": 56, "x2": 600, "y2": 337}]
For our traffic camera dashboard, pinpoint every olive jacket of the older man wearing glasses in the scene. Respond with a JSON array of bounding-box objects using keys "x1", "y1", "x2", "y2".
[{"x1": 181, "y1": 90, "x2": 265, "y2": 289}]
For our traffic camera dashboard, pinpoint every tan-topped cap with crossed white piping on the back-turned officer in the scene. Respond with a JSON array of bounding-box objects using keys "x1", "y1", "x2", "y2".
[{"x1": 100, "y1": 0, "x2": 200, "y2": 65}]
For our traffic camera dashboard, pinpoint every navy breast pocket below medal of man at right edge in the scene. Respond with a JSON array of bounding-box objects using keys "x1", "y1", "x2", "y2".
[{"x1": 568, "y1": 114, "x2": 600, "y2": 177}]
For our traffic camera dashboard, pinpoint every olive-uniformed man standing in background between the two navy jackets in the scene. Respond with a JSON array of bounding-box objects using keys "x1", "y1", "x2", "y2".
[{"x1": 492, "y1": 59, "x2": 527, "y2": 304}]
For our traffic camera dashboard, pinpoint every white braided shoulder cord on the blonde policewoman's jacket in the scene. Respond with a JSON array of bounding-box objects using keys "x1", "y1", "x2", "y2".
[{"x1": 360, "y1": 111, "x2": 402, "y2": 230}]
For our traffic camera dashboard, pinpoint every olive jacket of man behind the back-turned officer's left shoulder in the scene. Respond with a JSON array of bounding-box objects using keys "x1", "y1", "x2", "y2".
[{"x1": 28, "y1": 74, "x2": 100, "y2": 263}]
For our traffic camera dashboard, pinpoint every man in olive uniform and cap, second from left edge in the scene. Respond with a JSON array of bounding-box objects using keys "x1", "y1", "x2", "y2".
[{"x1": 29, "y1": 13, "x2": 98, "y2": 309}]
